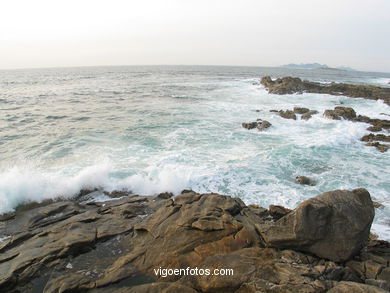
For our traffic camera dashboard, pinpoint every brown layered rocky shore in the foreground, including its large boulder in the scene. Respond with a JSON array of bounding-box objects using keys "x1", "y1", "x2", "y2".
[{"x1": 0, "y1": 189, "x2": 390, "y2": 293}]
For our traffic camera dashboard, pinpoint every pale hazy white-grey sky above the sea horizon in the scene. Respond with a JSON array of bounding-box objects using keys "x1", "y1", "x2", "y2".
[{"x1": 0, "y1": 0, "x2": 390, "y2": 72}]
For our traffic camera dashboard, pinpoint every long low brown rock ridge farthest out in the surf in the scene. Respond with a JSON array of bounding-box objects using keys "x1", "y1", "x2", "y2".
[{"x1": 260, "y1": 76, "x2": 390, "y2": 105}]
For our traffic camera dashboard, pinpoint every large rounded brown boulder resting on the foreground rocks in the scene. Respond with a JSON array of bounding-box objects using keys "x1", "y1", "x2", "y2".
[{"x1": 262, "y1": 189, "x2": 375, "y2": 262}]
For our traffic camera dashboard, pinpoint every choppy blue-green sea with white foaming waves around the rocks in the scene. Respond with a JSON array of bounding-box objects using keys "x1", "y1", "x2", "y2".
[{"x1": 0, "y1": 66, "x2": 390, "y2": 240}]
